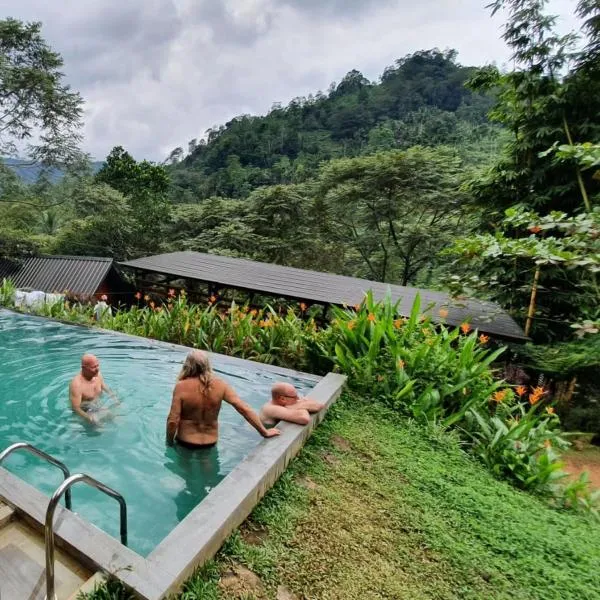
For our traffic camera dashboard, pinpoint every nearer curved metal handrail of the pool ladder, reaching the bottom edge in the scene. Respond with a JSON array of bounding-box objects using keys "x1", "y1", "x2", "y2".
[{"x1": 44, "y1": 473, "x2": 127, "y2": 600}]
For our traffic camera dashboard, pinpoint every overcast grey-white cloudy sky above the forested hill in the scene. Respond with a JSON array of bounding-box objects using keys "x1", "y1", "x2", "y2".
[{"x1": 0, "y1": 0, "x2": 576, "y2": 160}]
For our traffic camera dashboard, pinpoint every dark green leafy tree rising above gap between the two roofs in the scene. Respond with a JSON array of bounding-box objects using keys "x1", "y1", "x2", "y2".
[{"x1": 95, "y1": 146, "x2": 171, "y2": 254}]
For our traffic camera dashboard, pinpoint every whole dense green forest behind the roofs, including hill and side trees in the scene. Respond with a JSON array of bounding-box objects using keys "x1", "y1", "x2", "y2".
[{"x1": 0, "y1": 0, "x2": 600, "y2": 430}]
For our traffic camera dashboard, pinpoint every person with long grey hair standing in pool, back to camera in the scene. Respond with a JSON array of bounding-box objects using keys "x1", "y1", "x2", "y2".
[{"x1": 167, "y1": 350, "x2": 279, "y2": 448}]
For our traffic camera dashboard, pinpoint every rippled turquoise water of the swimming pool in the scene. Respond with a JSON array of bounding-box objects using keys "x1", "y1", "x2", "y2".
[{"x1": 0, "y1": 310, "x2": 314, "y2": 556}]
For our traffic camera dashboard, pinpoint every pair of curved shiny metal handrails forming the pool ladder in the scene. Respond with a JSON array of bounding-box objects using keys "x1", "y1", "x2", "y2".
[{"x1": 0, "y1": 442, "x2": 127, "y2": 600}]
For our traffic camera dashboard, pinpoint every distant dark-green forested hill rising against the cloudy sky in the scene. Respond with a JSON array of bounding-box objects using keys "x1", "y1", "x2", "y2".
[{"x1": 168, "y1": 50, "x2": 498, "y2": 202}]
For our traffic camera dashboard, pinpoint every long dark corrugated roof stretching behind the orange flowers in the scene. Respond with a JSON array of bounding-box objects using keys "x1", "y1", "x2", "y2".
[{"x1": 119, "y1": 251, "x2": 527, "y2": 340}]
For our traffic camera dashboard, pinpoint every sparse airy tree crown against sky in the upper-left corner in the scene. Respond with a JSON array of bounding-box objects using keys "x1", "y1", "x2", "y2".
[{"x1": 0, "y1": 18, "x2": 83, "y2": 165}]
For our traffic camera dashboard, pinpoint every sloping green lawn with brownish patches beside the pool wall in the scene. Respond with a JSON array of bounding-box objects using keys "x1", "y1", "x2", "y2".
[{"x1": 84, "y1": 397, "x2": 600, "y2": 600}]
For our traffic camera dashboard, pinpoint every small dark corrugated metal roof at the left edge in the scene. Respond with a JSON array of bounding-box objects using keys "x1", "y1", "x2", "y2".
[{"x1": 0, "y1": 256, "x2": 113, "y2": 295}]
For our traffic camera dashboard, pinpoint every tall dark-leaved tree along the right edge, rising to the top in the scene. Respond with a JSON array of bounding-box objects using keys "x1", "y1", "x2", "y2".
[{"x1": 454, "y1": 0, "x2": 600, "y2": 342}]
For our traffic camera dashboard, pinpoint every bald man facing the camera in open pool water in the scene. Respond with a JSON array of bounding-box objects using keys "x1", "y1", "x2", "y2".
[{"x1": 69, "y1": 354, "x2": 119, "y2": 425}]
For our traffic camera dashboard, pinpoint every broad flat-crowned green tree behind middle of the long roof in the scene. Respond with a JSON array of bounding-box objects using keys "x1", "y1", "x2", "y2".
[{"x1": 319, "y1": 147, "x2": 467, "y2": 285}]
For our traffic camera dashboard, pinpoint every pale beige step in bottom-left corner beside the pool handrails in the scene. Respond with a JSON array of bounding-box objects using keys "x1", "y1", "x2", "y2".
[{"x1": 0, "y1": 516, "x2": 93, "y2": 600}]
